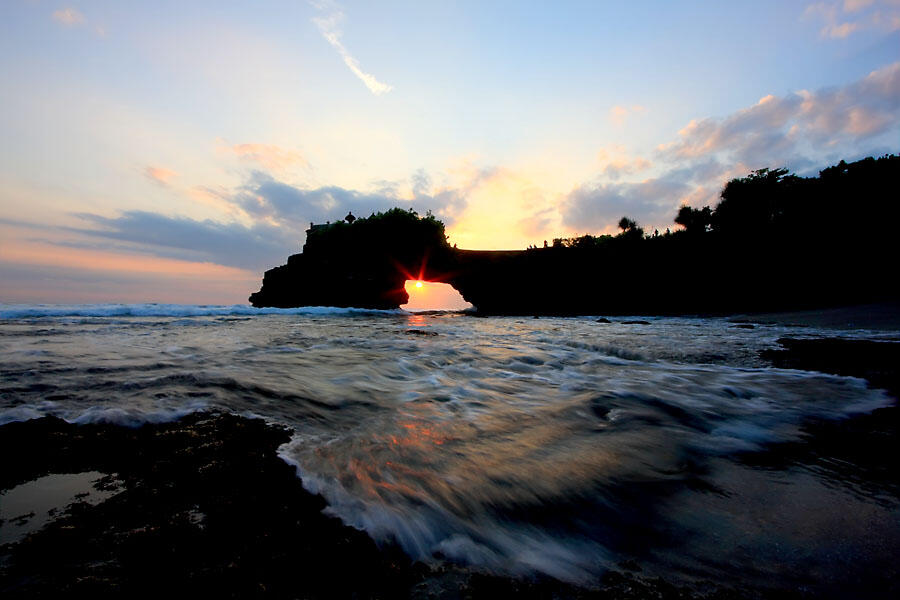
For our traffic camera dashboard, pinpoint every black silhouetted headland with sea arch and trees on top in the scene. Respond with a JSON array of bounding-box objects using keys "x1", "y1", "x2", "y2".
[{"x1": 250, "y1": 155, "x2": 900, "y2": 314}]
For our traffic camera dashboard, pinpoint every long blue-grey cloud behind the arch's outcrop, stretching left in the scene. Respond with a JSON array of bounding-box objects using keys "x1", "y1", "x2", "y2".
[{"x1": 51, "y1": 171, "x2": 465, "y2": 271}]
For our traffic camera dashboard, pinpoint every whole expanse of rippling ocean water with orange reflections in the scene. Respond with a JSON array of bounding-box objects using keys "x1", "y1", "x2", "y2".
[{"x1": 0, "y1": 304, "x2": 900, "y2": 589}]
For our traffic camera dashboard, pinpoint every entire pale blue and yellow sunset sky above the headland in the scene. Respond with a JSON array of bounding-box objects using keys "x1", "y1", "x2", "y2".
[{"x1": 0, "y1": 0, "x2": 900, "y2": 304}]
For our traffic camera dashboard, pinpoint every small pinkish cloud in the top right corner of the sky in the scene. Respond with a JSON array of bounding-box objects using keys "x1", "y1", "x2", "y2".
[{"x1": 803, "y1": 0, "x2": 900, "y2": 39}]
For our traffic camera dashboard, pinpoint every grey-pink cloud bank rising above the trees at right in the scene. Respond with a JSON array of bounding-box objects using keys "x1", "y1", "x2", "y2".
[{"x1": 559, "y1": 62, "x2": 900, "y2": 232}]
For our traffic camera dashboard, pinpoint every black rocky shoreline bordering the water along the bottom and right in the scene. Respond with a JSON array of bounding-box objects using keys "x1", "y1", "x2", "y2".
[{"x1": 0, "y1": 339, "x2": 900, "y2": 598}]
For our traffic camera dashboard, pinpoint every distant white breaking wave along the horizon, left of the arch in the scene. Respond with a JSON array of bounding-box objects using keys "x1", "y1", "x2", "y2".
[{"x1": 0, "y1": 303, "x2": 407, "y2": 319}]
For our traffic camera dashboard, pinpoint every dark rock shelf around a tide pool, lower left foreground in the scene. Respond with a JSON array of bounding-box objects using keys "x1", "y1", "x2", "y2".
[{"x1": 0, "y1": 414, "x2": 411, "y2": 597}]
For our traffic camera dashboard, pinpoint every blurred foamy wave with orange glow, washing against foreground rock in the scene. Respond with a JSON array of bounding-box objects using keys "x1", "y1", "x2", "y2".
[{"x1": 278, "y1": 362, "x2": 892, "y2": 583}]
